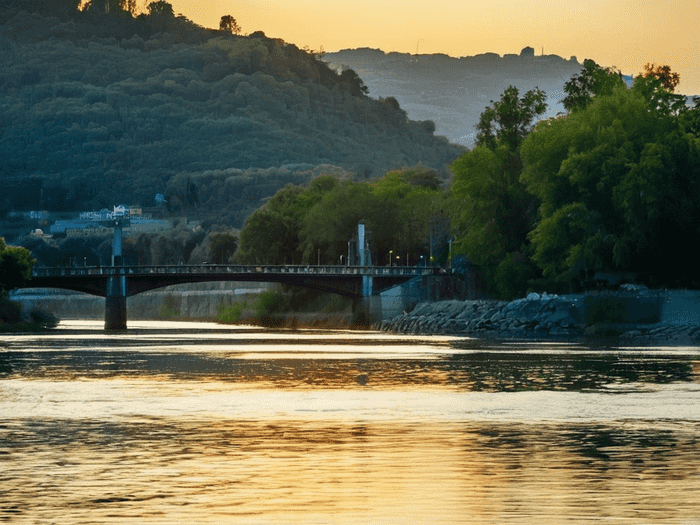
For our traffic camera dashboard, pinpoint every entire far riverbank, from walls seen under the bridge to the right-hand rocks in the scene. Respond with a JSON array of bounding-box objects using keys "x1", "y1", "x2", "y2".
[{"x1": 9, "y1": 290, "x2": 700, "y2": 346}]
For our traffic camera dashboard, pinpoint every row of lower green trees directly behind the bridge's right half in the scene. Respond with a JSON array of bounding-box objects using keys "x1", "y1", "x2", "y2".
[{"x1": 236, "y1": 166, "x2": 449, "y2": 265}]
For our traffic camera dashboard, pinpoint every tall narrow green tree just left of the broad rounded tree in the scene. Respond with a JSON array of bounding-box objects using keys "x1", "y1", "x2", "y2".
[{"x1": 452, "y1": 86, "x2": 546, "y2": 299}]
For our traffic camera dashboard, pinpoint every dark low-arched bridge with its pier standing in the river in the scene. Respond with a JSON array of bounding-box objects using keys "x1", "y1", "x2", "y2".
[{"x1": 24, "y1": 265, "x2": 439, "y2": 330}]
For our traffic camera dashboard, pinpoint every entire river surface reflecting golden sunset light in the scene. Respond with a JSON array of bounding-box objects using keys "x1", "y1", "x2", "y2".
[{"x1": 0, "y1": 321, "x2": 700, "y2": 524}]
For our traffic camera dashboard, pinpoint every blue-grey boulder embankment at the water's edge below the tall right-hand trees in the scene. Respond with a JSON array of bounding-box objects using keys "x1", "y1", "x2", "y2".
[{"x1": 374, "y1": 292, "x2": 700, "y2": 346}]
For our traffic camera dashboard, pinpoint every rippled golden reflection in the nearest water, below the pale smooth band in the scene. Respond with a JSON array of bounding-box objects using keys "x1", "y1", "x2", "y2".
[{"x1": 0, "y1": 418, "x2": 700, "y2": 524}]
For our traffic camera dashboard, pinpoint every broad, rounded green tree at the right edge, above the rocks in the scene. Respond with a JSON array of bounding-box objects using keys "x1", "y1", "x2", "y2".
[{"x1": 522, "y1": 69, "x2": 700, "y2": 285}]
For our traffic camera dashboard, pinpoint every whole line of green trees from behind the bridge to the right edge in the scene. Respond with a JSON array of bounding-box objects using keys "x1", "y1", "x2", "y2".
[{"x1": 236, "y1": 60, "x2": 700, "y2": 299}]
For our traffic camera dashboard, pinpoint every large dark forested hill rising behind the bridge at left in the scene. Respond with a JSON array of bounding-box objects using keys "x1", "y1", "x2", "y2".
[{"x1": 0, "y1": 5, "x2": 462, "y2": 226}]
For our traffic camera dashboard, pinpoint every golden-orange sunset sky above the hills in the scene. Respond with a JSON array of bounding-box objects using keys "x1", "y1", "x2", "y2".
[{"x1": 167, "y1": 0, "x2": 700, "y2": 95}]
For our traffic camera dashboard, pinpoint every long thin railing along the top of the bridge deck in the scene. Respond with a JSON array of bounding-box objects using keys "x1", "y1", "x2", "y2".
[{"x1": 32, "y1": 264, "x2": 439, "y2": 277}]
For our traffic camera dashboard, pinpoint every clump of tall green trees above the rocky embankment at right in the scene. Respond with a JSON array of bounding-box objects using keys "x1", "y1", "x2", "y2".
[{"x1": 453, "y1": 60, "x2": 700, "y2": 298}]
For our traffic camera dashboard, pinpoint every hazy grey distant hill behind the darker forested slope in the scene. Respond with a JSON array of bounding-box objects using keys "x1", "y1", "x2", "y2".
[{"x1": 324, "y1": 47, "x2": 581, "y2": 147}]
